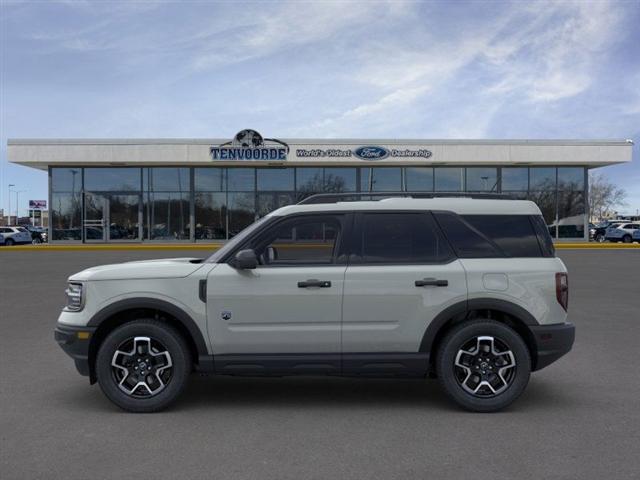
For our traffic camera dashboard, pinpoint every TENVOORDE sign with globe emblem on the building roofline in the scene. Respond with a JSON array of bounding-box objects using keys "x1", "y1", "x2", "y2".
[{"x1": 211, "y1": 130, "x2": 289, "y2": 161}]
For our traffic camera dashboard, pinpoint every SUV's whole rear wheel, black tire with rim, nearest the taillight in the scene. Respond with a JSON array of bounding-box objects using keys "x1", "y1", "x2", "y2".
[{"x1": 436, "y1": 319, "x2": 531, "y2": 412}]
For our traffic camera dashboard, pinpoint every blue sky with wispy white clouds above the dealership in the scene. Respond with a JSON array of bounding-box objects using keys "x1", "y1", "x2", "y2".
[{"x1": 0, "y1": 0, "x2": 640, "y2": 214}]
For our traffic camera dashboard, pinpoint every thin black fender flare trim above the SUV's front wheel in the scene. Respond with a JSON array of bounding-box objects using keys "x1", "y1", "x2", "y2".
[{"x1": 87, "y1": 297, "x2": 209, "y2": 356}]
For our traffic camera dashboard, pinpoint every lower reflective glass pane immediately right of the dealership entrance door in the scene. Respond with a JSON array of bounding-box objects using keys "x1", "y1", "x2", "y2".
[{"x1": 144, "y1": 192, "x2": 189, "y2": 240}]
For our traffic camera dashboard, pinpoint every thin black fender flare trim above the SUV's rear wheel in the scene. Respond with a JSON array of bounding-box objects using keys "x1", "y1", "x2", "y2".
[{"x1": 420, "y1": 298, "x2": 539, "y2": 353}]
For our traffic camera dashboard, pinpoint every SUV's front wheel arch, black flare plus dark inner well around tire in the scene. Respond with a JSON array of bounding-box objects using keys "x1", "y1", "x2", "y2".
[{"x1": 87, "y1": 298, "x2": 209, "y2": 384}]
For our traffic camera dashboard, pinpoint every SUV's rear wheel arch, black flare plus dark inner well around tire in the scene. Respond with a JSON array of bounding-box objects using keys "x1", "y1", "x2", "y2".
[{"x1": 420, "y1": 298, "x2": 539, "y2": 373}]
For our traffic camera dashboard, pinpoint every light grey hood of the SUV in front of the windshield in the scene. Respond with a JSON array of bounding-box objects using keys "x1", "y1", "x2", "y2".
[{"x1": 69, "y1": 258, "x2": 202, "y2": 282}]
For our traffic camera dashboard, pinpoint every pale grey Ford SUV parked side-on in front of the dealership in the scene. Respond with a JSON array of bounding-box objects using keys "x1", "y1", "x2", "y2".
[{"x1": 55, "y1": 195, "x2": 574, "y2": 412}]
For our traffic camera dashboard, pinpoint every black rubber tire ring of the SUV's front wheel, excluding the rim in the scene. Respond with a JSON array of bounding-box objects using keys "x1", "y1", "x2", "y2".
[{"x1": 96, "y1": 320, "x2": 191, "y2": 413}]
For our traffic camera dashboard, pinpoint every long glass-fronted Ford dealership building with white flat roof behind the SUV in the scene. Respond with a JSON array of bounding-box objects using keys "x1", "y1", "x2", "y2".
[{"x1": 8, "y1": 130, "x2": 633, "y2": 243}]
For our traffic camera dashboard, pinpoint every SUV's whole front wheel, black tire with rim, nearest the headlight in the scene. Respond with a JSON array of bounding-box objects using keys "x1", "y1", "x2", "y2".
[{"x1": 96, "y1": 319, "x2": 192, "y2": 413}]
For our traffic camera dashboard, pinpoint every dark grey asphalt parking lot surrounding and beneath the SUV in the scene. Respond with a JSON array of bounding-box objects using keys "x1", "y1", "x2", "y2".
[{"x1": 0, "y1": 250, "x2": 640, "y2": 480}]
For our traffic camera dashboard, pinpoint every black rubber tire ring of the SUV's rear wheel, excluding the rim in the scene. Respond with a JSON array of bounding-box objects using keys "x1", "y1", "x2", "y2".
[{"x1": 436, "y1": 320, "x2": 531, "y2": 412}]
